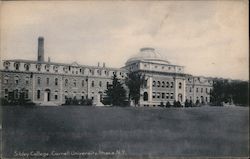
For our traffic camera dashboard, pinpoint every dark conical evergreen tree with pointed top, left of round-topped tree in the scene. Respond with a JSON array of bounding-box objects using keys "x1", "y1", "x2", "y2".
[{"x1": 105, "y1": 74, "x2": 127, "y2": 106}]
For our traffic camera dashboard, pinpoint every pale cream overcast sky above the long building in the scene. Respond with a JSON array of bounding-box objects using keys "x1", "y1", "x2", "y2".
[{"x1": 0, "y1": 0, "x2": 249, "y2": 80}]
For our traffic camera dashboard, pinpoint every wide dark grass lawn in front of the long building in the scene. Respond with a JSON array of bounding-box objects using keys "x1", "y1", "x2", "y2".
[{"x1": 2, "y1": 106, "x2": 249, "y2": 158}]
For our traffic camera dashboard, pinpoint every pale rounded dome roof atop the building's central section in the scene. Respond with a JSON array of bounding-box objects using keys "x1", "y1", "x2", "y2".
[{"x1": 126, "y1": 47, "x2": 170, "y2": 64}]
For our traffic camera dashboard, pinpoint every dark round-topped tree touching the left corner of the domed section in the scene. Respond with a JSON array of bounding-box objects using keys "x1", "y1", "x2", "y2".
[{"x1": 126, "y1": 72, "x2": 146, "y2": 105}]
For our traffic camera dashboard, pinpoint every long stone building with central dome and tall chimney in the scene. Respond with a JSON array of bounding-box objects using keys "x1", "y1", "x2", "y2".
[{"x1": 0, "y1": 37, "x2": 213, "y2": 106}]
